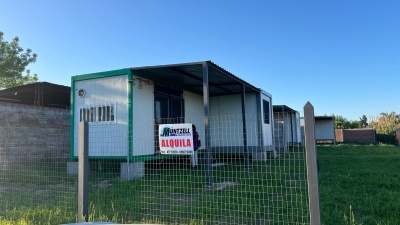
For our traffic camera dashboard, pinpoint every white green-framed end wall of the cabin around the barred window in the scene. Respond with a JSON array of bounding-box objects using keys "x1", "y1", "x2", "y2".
[{"x1": 74, "y1": 75, "x2": 128, "y2": 157}]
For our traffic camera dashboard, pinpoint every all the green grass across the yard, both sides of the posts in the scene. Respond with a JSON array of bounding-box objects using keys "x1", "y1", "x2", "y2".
[{"x1": 0, "y1": 145, "x2": 400, "y2": 225}]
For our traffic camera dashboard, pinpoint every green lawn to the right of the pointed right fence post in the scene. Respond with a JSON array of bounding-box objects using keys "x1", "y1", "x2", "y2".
[{"x1": 318, "y1": 145, "x2": 400, "y2": 225}]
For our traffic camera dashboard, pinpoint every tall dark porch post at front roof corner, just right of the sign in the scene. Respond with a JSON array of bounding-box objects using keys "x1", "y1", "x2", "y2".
[{"x1": 202, "y1": 62, "x2": 212, "y2": 187}]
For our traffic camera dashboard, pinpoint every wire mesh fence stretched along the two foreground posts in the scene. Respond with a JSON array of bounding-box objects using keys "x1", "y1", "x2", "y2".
[{"x1": 0, "y1": 106, "x2": 310, "y2": 224}]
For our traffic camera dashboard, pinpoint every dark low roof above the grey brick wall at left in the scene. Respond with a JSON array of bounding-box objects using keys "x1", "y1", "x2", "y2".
[{"x1": 0, "y1": 82, "x2": 71, "y2": 109}]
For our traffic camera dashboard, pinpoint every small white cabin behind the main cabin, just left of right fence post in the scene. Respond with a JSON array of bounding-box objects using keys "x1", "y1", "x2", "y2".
[{"x1": 273, "y1": 105, "x2": 303, "y2": 153}]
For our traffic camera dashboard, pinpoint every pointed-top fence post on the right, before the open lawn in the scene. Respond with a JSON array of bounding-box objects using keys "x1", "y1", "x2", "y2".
[{"x1": 304, "y1": 102, "x2": 321, "y2": 225}]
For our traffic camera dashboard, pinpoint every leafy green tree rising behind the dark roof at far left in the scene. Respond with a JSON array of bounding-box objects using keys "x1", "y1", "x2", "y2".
[{"x1": 0, "y1": 31, "x2": 38, "y2": 89}]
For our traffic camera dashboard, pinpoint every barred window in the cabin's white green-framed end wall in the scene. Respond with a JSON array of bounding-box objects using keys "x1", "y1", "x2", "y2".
[{"x1": 79, "y1": 104, "x2": 115, "y2": 122}]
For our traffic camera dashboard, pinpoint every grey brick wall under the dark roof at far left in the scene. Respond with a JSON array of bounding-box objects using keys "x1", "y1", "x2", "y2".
[{"x1": 0, "y1": 103, "x2": 70, "y2": 169}]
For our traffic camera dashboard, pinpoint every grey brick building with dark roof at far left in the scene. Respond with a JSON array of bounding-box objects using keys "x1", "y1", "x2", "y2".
[{"x1": 0, "y1": 82, "x2": 70, "y2": 170}]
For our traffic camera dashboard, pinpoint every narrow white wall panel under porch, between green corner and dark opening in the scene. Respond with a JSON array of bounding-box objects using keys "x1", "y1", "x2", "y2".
[{"x1": 132, "y1": 76, "x2": 156, "y2": 156}]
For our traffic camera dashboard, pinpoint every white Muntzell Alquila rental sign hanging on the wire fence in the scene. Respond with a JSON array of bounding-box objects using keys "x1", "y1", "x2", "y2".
[{"x1": 158, "y1": 123, "x2": 194, "y2": 155}]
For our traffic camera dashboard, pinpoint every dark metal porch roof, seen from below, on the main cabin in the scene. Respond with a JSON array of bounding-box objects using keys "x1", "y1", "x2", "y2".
[{"x1": 130, "y1": 61, "x2": 261, "y2": 96}]
